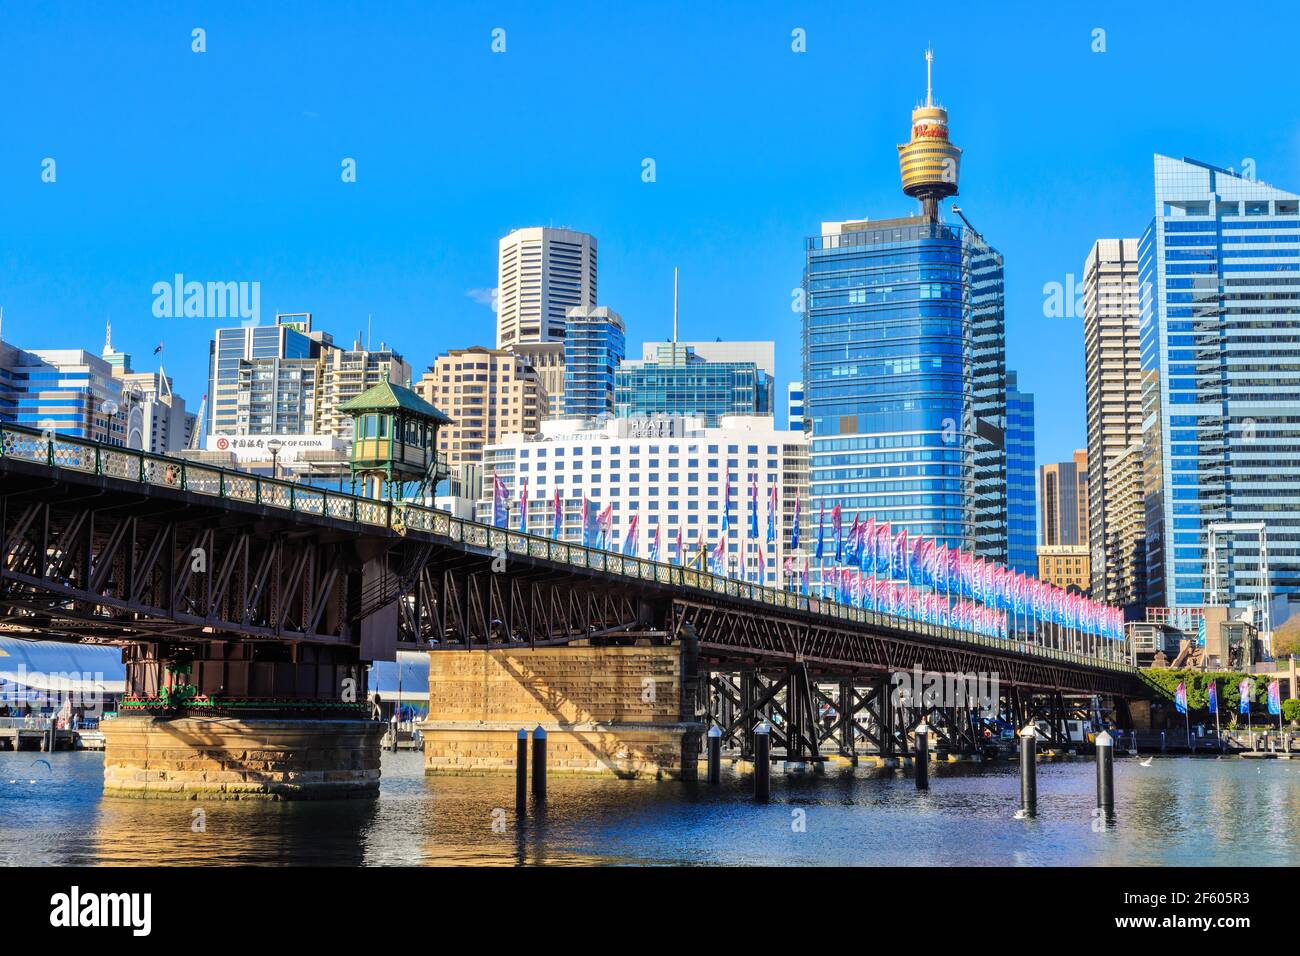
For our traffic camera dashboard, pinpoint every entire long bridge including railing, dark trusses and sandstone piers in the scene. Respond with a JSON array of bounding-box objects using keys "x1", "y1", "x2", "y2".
[{"x1": 0, "y1": 425, "x2": 1147, "y2": 797}]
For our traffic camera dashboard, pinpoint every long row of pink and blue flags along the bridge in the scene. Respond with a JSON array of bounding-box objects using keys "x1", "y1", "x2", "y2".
[{"x1": 493, "y1": 475, "x2": 1123, "y2": 640}]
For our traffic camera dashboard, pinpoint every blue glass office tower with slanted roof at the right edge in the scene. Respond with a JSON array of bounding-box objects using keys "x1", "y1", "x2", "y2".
[{"x1": 1138, "y1": 156, "x2": 1300, "y2": 621}]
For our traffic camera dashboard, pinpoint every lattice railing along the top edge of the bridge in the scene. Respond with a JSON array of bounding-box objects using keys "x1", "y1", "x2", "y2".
[{"x1": 0, "y1": 424, "x2": 1134, "y2": 672}]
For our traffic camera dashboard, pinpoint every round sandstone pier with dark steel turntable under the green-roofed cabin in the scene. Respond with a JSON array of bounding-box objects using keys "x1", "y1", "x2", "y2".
[{"x1": 100, "y1": 643, "x2": 385, "y2": 800}]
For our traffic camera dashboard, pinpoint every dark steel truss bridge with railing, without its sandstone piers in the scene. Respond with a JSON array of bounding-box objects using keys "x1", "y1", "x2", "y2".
[{"x1": 0, "y1": 425, "x2": 1147, "y2": 754}]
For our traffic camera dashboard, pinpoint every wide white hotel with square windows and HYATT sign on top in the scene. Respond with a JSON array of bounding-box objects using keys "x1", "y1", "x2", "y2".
[{"x1": 477, "y1": 415, "x2": 816, "y2": 587}]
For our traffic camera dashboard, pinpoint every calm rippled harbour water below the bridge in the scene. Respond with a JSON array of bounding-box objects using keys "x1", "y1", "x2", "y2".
[{"x1": 0, "y1": 753, "x2": 1300, "y2": 866}]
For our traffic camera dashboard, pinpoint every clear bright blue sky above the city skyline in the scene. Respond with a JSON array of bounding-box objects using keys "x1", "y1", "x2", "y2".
[{"x1": 0, "y1": 3, "x2": 1300, "y2": 473}]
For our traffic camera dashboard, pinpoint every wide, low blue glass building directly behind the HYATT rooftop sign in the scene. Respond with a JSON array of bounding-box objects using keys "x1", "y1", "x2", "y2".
[{"x1": 614, "y1": 342, "x2": 772, "y2": 427}]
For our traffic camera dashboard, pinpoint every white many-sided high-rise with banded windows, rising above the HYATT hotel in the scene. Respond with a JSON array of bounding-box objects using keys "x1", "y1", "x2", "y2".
[{"x1": 497, "y1": 226, "x2": 595, "y2": 349}]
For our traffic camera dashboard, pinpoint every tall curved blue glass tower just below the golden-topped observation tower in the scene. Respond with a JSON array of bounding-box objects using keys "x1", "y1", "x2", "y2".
[{"x1": 803, "y1": 216, "x2": 1008, "y2": 562}]
